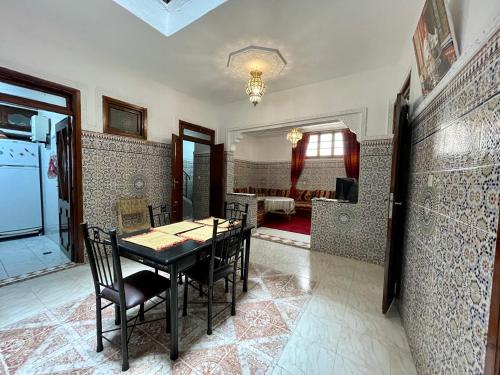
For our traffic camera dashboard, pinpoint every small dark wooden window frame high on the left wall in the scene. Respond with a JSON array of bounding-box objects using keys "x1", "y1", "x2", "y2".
[{"x1": 102, "y1": 95, "x2": 148, "y2": 140}]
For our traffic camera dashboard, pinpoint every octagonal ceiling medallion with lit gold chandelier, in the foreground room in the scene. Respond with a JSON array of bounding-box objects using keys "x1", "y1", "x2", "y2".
[{"x1": 227, "y1": 46, "x2": 287, "y2": 106}]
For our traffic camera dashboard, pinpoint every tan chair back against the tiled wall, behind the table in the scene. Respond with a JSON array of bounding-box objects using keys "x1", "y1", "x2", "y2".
[{"x1": 116, "y1": 198, "x2": 151, "y2": 233}]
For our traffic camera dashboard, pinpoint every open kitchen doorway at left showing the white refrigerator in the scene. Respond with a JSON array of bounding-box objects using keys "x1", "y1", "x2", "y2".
[{"x1": 0, "y1": 68, "x2": 82, "y2": 284}]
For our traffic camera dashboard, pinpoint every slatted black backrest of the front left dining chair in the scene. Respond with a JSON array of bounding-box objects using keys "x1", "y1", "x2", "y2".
[{"x1": 81, "y1": 223, "x2": 125, "y2": 301}]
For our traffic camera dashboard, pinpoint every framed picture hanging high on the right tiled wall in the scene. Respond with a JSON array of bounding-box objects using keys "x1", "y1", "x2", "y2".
[{"x1": 413, "y1": 0, "x2": 458, "y2": 95}]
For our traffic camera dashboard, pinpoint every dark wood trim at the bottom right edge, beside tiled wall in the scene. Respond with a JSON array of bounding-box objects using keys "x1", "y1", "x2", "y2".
[{"x1": 484, "y1": 223, "x2": 500, "y2": 375}]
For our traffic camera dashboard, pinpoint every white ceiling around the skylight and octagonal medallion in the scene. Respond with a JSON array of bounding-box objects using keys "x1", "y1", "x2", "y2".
[{"x1": 0, "y1": 0, "x2": 421, "y2": 104}]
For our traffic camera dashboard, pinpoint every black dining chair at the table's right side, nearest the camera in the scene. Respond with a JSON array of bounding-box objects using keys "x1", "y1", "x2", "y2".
[{"x1": 182, "y1": 214, "x2": 246, "y2": 335}]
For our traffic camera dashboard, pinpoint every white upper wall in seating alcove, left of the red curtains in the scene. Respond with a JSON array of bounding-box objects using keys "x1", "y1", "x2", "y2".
[{"x1": 234, "y1": 135, "x2": 292, "y2": 162}]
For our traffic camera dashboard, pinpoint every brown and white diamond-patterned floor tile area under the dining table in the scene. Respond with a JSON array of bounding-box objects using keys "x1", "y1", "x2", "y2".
[{"x1": 0, "y1": 264, "x2": 315, "y2": 373}]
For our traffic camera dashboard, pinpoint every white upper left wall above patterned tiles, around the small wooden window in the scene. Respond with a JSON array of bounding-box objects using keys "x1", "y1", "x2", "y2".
[{"x1": 0, "y1": 13, "x2": 216, "y2": 142}]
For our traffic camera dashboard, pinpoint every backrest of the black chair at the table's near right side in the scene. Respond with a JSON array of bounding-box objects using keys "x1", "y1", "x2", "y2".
[{"x1": 209, "y1": 213, "x2": 247, "y2": 283}]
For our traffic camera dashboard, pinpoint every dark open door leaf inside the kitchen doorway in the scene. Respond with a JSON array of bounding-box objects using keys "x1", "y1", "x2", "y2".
[{"x1": 56, "y1": 117, "x2": 73, "y2": 259}]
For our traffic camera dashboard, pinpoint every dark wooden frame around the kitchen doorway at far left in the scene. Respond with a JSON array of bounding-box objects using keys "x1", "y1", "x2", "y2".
[{"x1": 0, "y1": 67, "x2": 85, "y2": 263}]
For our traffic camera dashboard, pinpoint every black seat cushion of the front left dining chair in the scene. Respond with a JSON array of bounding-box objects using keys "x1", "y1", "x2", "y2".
[{"x1": 101, "y1": 270, "x2": 170, "y2": 309}]
